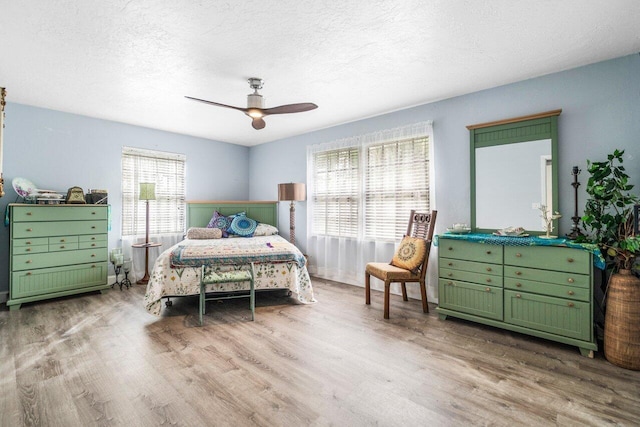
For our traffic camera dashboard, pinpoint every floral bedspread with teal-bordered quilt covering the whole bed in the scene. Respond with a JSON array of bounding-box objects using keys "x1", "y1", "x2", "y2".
[{"x1": 144, "y1": 235, "x2": 316, "y2": 316}]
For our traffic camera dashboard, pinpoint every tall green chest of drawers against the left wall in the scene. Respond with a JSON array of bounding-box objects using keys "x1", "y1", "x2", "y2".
[{"x1": 7, "y1": 204, "x2": 109, "y2": 310}]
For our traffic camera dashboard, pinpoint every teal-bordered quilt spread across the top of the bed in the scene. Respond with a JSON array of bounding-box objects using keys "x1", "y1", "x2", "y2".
[{"x1": 171, "y1": 236, "x2": 306, "y2": 268}]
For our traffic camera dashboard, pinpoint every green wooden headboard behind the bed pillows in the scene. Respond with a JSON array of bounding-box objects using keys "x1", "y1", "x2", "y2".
[{"x1": 187, "y1": 201, "x2": 278, "y2": 229}]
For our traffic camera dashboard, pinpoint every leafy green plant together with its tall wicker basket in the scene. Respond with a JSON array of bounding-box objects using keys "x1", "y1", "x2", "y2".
[{"x1": 582, "y1": 150, "x2": 640, "y2": 370}]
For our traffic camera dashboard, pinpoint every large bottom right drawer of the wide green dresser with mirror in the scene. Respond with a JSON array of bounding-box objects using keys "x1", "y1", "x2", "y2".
[{"x1": 504, "y1": 290, "x2": 593, "y2": 341}]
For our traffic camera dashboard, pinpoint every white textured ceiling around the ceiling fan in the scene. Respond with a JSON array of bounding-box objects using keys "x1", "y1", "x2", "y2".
[{"x1": 0, "y1": 0, "x2": 640, "y2": 146}]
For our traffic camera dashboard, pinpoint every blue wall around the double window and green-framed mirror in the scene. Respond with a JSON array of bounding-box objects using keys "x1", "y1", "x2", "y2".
[{"x1": 250, "y1": 54, "x2": 640, "y2": 254}]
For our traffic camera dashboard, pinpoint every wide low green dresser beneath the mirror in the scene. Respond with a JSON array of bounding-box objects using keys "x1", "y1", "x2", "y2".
[{"x1": 436, "y1": 236, "x2": 598, "y2": 357}]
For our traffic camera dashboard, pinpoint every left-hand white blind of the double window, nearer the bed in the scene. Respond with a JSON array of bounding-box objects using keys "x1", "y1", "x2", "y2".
[{"x1": 312, "y1": 147, "x2": 360, "y2": 237}]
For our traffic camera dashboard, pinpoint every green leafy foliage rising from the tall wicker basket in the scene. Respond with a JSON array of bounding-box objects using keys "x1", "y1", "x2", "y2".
[{"x1": 582, "y1": 150, "x2": 640, "y2": 270}]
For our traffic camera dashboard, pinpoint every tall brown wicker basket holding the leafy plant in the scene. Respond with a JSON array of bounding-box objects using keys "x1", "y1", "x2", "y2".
[{"x1": 604, "y1": 270, "x2": 640, "y2": 370}]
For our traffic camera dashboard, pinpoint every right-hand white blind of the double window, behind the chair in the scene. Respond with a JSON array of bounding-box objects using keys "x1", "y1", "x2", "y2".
[{"x1": 364, "y1": 137, "x2": 429, "y2": 240}]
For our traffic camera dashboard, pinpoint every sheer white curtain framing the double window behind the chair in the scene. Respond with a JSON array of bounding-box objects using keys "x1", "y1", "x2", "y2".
[{"x1": 307, "y1": 121, "x2": 437, "y2": 297}]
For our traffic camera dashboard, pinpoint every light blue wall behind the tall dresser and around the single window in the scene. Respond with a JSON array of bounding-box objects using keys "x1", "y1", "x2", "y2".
[{"x1": 0, "y1": 102, "x2": 249, "y2": 300}]
